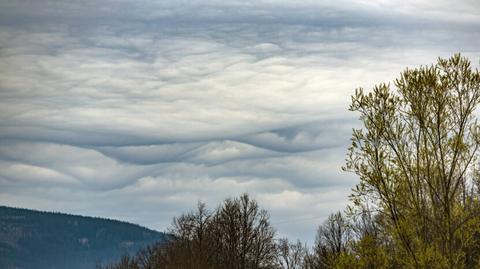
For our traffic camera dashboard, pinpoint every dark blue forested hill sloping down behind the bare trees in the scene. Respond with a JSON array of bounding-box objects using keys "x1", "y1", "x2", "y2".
[{"x1": 0, "y1": 206, "x2": 165, "y2": 269}]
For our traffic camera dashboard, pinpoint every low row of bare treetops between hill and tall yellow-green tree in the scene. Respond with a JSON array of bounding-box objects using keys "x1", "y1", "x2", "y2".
[{"x1": 94, "y1": 194, "x2": 416, "y2": 269}]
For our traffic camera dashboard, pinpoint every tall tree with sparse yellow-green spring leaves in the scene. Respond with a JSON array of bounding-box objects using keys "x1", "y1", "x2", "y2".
[{"x1": 345, "y1": 55, "x2": 480, "y2": 268}]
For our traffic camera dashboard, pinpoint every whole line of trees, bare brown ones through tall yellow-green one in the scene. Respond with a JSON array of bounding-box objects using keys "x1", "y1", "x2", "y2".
[{"x1": 107, "y1": 55, "x2": 480, "y2": 269}]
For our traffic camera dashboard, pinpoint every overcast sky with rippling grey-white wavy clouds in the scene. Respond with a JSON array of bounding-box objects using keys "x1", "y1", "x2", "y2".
[{"x1": 0, "y1": 0, "x2": 480, "y2": 243}]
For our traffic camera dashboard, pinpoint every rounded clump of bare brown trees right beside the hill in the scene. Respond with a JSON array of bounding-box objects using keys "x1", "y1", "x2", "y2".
[{"x1": 99, "y1": 195, "x2": 290, "y2": 269}]
